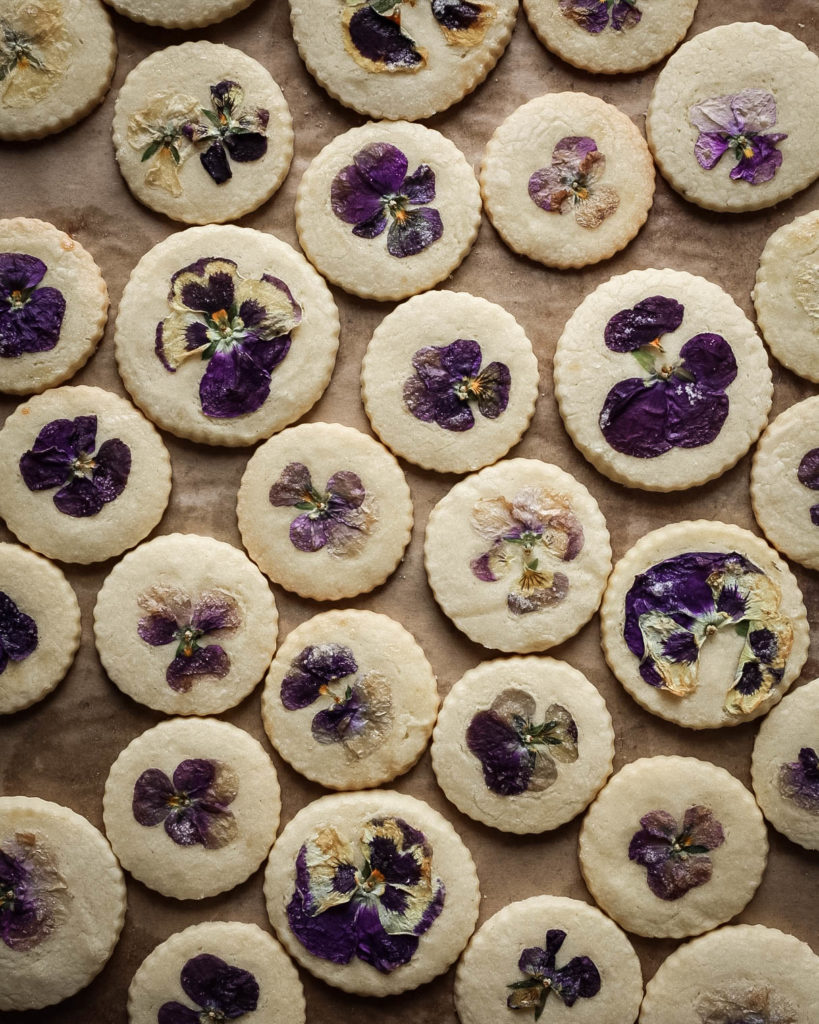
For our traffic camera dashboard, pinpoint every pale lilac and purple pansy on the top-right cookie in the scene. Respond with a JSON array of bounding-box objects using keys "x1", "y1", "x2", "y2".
[{"x1": 688, "y1": 89, "x2": 787, "y2": 185}]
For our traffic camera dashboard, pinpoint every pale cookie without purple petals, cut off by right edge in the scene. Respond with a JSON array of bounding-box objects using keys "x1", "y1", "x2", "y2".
[{"x1": 752, "y1": 210, "x2": 819, "y2": 382}]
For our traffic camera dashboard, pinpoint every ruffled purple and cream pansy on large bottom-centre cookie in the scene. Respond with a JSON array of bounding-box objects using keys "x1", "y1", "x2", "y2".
[{"x1": 287, "y1": 817, "x2": 445, "y2": 974}]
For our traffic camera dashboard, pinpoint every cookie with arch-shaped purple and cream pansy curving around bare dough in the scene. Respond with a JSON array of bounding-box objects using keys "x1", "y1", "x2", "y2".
[{"x1": 600, "y1": 520, "x2": 810, "y2": 729}]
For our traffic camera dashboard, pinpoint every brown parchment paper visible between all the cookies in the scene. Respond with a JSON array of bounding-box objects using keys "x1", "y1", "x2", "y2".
[{"x1": 0, "y1": 0, "x2": 819, "y2": 1024}]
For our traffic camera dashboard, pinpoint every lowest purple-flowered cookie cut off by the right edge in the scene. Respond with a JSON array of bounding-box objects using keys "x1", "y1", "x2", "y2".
[{"x1": 750, "y1": 679, "x2": 819, "y2": 850}]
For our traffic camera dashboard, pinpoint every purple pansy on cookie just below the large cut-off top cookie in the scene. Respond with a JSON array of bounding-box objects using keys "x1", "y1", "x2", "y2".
[{"x1": 330, "y1": 142, "x2": 443, "y2": 258}]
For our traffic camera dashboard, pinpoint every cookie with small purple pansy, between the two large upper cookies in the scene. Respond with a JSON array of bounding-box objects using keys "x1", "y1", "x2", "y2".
[{"x1": 361, "y1": 291, "x2": 538, "y2": 473}]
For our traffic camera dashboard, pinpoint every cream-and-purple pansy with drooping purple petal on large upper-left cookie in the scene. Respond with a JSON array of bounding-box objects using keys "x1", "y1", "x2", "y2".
[{"x1": 156, "y1": 256, "x2": 301, "y2": 419}]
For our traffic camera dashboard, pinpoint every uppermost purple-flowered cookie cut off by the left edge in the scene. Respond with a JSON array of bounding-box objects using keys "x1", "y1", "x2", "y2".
[{"x1": 0, "y1": 217, "x2": 109, "y2": 394}]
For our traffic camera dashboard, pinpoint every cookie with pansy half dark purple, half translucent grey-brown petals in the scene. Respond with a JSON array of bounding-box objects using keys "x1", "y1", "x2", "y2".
[{"x1": 432, "y1": 657, "x2": 614, "y2": 834}]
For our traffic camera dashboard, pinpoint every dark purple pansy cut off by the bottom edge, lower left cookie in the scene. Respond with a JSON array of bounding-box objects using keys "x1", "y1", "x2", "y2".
[{"x1": 157, "y1": 953, "x2": 259, "y2": 1024}]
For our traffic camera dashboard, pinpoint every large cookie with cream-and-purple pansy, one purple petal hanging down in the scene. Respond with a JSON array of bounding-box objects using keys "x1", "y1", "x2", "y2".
[{"x1": 114, "y1": 224, "x2": 339, "y2": 445}]
